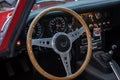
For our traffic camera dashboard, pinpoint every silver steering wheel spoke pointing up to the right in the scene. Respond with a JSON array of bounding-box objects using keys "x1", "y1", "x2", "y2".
[{"x1": 68, "y1": 27, "x2": 85, "y2": 43}]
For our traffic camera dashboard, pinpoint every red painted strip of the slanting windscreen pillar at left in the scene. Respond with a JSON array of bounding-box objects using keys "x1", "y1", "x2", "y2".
[{"x1": 0, "y1": 0, "x2": 27, "y2": 52}]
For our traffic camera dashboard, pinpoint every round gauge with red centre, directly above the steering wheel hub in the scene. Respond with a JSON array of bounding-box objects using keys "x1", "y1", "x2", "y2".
[{"x1": 49, "y1": 17, "x2": 67, "y2": 33}]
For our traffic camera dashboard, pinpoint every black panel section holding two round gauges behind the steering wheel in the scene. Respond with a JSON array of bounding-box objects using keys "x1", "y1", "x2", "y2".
[{"x1": 24, "y1": 16, "x2": 71, "y2": 38}]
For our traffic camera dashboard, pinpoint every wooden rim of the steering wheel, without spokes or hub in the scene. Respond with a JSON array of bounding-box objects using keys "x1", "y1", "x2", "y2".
[{"x1": 26, "y1": 7, "x2": 92, "y2": 80}]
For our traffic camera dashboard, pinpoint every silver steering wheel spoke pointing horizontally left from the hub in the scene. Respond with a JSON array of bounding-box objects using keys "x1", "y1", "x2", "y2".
[{"x1": 32, "y1": 38, "x2": 52, "y2": 48}]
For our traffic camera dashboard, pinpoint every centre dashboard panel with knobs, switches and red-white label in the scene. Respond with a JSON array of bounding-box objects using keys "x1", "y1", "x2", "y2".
[{"x1": 80, "y1": 12, "x2": 111, "y2": 53}]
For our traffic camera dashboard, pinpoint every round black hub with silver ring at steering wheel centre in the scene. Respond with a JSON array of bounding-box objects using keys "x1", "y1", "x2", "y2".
[{"x1": 52, "y1": 32, "x2": 72, "y2": 53}]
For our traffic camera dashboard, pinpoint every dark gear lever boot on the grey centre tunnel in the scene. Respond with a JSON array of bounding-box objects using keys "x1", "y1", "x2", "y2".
[{"x1": 91, "y1": 51, "x2": 112, "y2": 73}]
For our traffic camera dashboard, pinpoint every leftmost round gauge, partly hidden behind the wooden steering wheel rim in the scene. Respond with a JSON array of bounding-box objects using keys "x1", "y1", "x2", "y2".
[{"x1": 25, "y1": 23, "x2": 43, "y2": 39}]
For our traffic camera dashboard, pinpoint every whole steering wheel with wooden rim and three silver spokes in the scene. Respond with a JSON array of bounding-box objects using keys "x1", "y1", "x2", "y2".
[{"x1": 26, "y1": 7, "x2": 92, "y2": 80}]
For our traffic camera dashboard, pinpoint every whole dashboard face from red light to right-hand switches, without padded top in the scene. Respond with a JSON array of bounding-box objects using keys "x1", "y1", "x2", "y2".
[{"x1": 16, "y1": 11, "x2": 111, "y2": 53}]
